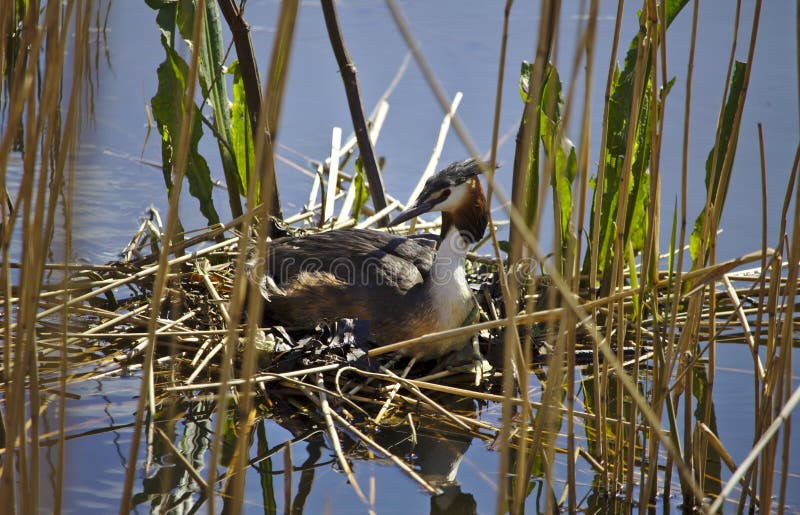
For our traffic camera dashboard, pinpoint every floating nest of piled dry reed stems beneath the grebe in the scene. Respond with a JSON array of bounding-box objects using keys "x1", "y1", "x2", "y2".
[{"x1": 12, "y1": 207, "x2": 792, "y2": 500}]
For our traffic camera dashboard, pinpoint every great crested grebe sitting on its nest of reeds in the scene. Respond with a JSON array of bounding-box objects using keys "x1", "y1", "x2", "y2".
[{"x1": 252, "y1": 159, "x2": 487, "y2": 359}]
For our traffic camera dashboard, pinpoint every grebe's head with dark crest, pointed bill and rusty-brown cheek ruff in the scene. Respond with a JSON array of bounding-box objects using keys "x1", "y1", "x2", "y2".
[{"x1": 389, "y1": 159, "x2": 487, "y2": 243}]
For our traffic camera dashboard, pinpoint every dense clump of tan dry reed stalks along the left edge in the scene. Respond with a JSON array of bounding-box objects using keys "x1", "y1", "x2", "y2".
[{"x1": 0, "y1": 1, "x2": 93, "y2": 512}]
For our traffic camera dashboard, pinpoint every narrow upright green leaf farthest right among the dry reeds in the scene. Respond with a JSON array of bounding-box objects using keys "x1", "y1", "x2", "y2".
[{"x1": 689, "y1": 61, "x2": 747, "y2": 268}]
